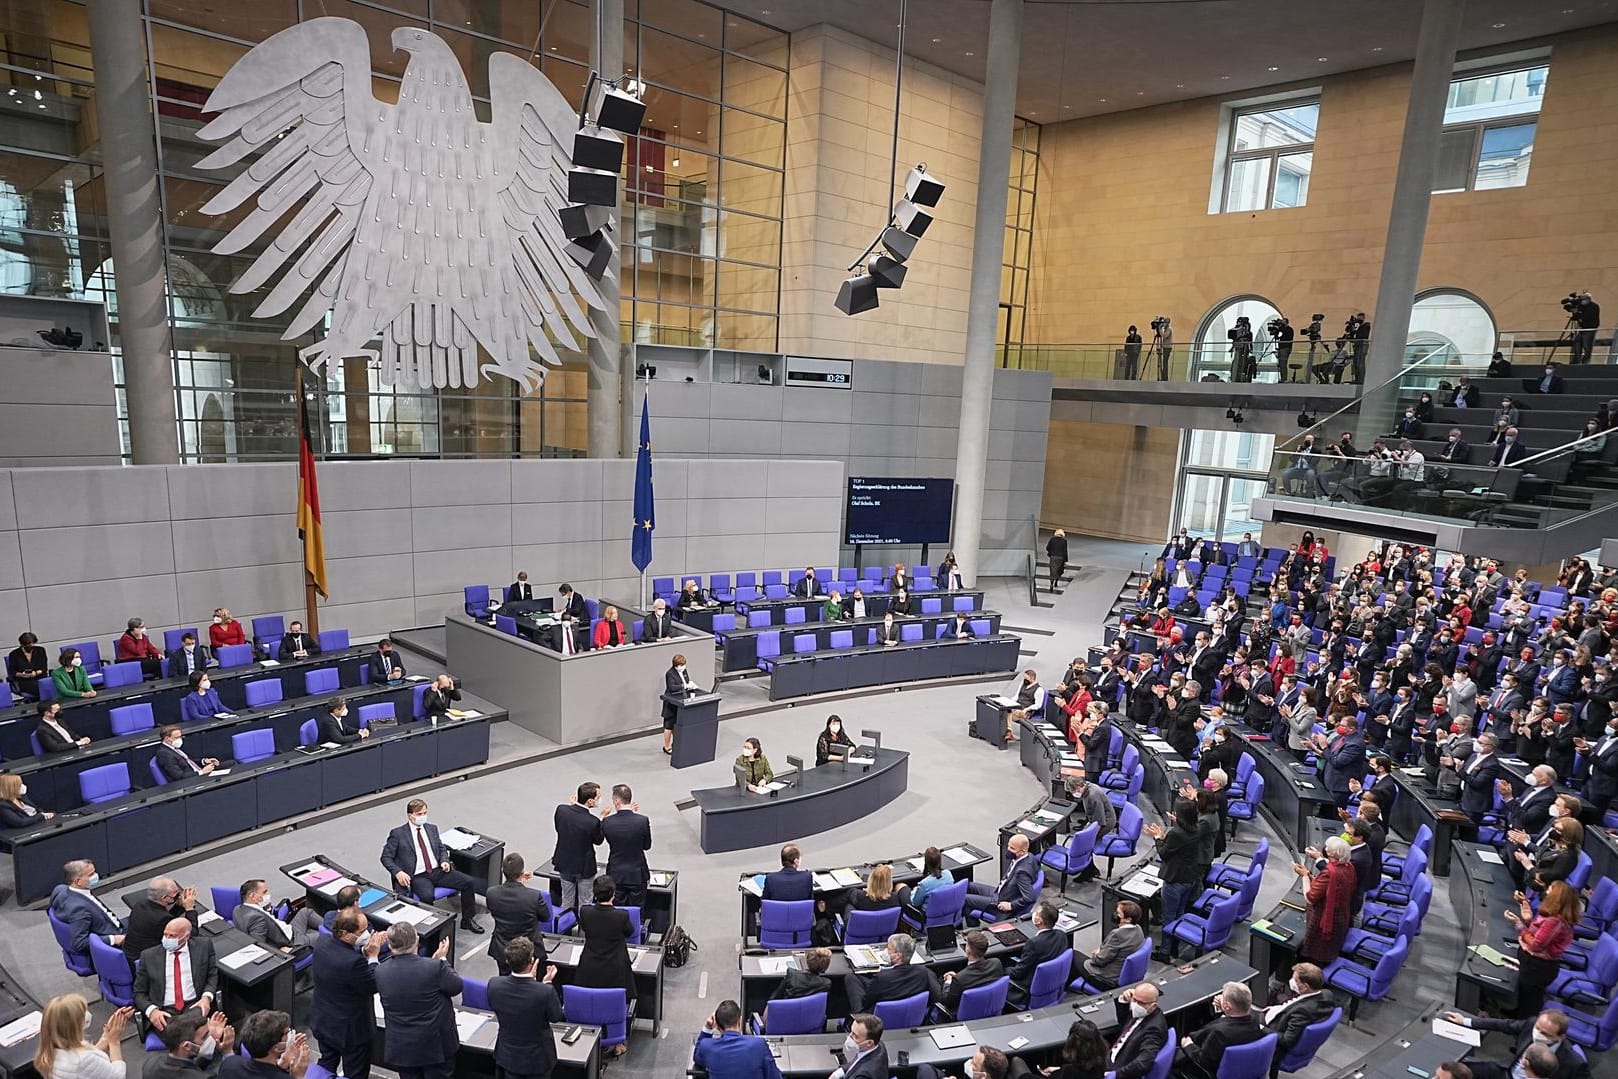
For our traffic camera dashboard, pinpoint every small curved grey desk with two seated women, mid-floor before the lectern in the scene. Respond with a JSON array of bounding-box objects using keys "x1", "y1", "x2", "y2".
[{"x1": 691, "y1": 746, "x2": 909, "y2": 854}]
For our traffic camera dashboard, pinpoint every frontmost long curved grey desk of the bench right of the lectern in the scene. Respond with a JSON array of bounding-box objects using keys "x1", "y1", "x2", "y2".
[{"x1": 770, "y1": 633, "x2": 1023, "y2": 700}]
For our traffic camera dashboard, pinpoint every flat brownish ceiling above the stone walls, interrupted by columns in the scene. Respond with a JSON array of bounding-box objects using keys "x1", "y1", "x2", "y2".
[{"x1": 710, "y1": 0, "x2": 1618, "y2": 123}]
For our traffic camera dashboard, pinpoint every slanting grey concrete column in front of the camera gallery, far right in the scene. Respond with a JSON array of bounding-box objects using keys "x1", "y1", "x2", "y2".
[{"x1": 1359, "y1": 0, "x2": 1466, "y2": 446}]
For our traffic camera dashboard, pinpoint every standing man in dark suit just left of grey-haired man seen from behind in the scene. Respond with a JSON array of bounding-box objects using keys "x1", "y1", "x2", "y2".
[{"x1": 309, "y1": 908, "x2": 383, "y2": 1079}]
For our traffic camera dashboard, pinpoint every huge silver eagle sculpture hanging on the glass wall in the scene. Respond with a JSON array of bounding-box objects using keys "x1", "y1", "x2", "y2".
[{"x1": 199, "y1": 18, "x2": 604, "y2": 388}]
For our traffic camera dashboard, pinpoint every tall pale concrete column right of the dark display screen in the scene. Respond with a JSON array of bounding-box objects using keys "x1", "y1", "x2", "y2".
[{"x1": 944, "y1": 0, "x2": 1023, "y2": 582}]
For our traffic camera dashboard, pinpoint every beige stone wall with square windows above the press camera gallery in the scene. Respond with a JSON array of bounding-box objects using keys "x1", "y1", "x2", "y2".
[{"x1": 1027, "y1": 29, "x2": 1618, "y2": 347}]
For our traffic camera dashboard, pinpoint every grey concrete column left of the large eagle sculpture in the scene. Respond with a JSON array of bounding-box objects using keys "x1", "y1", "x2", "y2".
[{"x1": 89, "y1": 0, "x2": 180, "y2": 464}]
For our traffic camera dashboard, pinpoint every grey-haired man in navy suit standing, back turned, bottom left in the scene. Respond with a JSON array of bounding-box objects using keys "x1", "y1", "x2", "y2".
[{"x1": 375, "y1": 922, "x2": 461, "y2": 1079}]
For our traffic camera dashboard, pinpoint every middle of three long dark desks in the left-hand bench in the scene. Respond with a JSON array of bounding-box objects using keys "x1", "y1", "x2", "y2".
[{"x1": 5, "y1": 683, "x2": 416, "y2": 812}]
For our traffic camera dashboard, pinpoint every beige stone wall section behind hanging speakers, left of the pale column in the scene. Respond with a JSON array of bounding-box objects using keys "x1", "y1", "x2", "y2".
[{"x1": 781, "y1": 26, "x2": 982, "y2": 364}]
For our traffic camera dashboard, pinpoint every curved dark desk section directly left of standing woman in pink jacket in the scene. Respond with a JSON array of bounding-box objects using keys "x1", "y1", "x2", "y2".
[{"x1": 1450, "y1": 840, "x2": 1518, "y2": 1014}]
